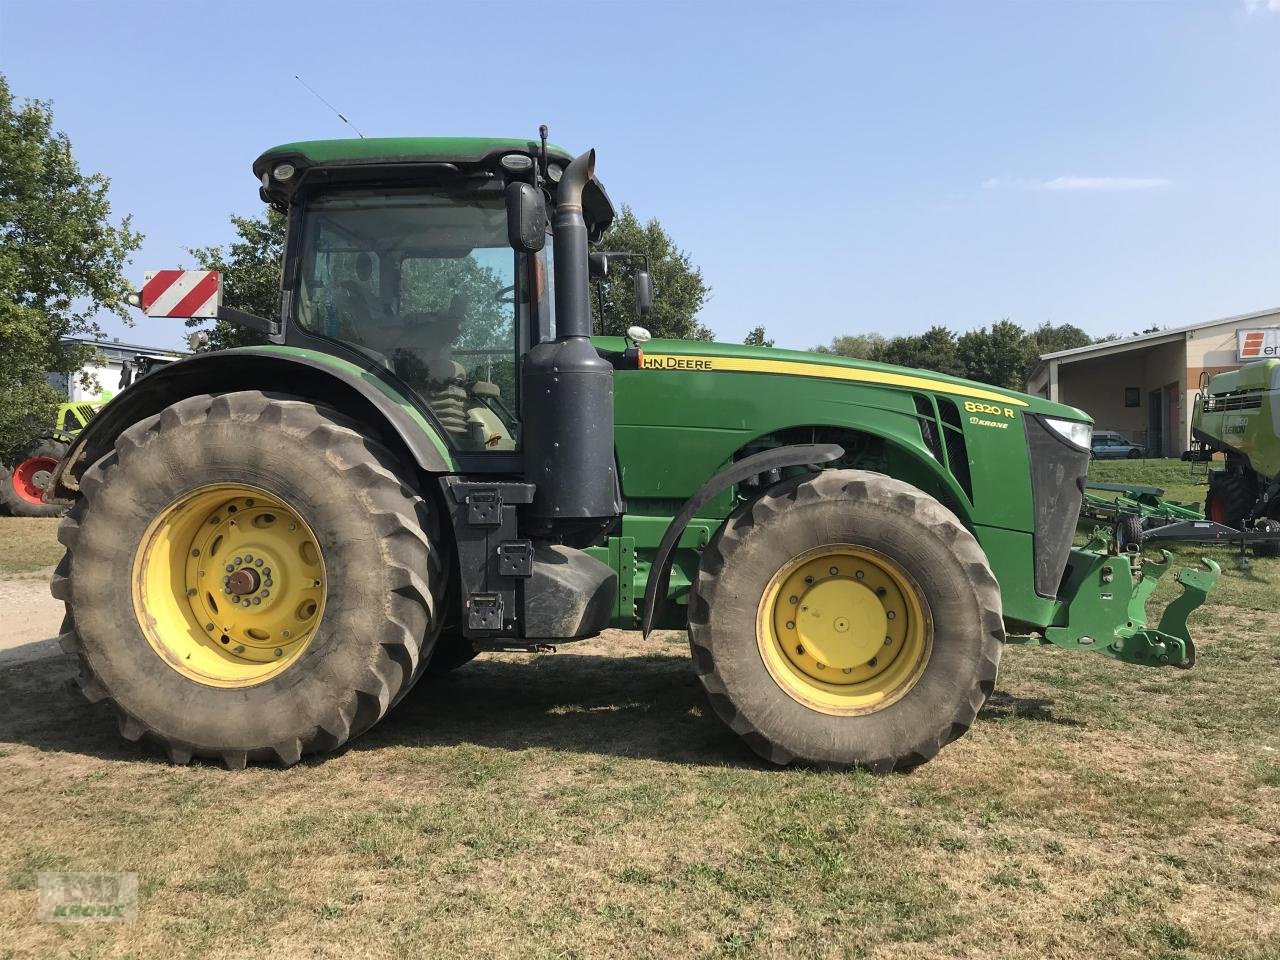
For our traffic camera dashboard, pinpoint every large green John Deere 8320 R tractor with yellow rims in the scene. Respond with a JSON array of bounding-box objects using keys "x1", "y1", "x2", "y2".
[{"x1": 52, "y1": 136, "x2": 1216, "y2": 771}]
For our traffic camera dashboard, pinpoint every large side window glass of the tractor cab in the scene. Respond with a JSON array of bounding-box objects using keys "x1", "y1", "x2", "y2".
[{"x1": 294, "y1": 191, "x2": 524, "y2": 451}]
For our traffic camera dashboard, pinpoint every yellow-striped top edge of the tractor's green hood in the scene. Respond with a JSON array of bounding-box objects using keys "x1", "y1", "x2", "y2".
[{"x1": 624, "y1": 338, "x2": 1093, "y2": 424}]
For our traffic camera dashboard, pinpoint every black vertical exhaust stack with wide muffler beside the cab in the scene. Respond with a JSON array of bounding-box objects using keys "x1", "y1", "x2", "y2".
[{"x1": 521, "y1": 150, "x2": 622, "y2": 545}]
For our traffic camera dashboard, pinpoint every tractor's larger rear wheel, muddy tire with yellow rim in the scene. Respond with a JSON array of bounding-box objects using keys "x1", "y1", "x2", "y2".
[{"x1": 51, "y1": 390, "x2": 447, "y2": 768}]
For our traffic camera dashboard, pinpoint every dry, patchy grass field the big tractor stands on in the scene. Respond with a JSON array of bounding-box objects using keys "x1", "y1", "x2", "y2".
[{"x1": 0, "y1": 463, "x2": 1280, "y2": 960}]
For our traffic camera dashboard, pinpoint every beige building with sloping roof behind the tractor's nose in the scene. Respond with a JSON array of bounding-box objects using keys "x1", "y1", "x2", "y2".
[{"x1": 1027, "y1": 308, "x2": 1280, "y2": 457}]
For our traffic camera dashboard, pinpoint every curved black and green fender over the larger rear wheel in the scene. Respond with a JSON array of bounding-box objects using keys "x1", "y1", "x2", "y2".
[{"x1": 45, "y1": 347, "x2": 457, "y2": 499}]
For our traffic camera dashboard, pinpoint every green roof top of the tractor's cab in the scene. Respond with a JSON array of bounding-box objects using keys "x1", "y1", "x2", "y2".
[{"x1": 253, "y1": 137, "x2": 573, "y2": 177}]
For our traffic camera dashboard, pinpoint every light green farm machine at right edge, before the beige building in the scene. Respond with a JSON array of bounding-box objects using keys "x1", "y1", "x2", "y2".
[{"x1": 1192, "y1": 360, "x2": 1280, "y2": 557}]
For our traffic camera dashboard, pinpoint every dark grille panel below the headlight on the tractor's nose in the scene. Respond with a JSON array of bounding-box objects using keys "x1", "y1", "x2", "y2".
[{"x1": 1023, "y1": 415, "x2": 1089, "y2": 599}]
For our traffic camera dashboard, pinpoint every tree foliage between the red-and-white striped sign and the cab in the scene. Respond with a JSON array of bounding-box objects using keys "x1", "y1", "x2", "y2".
[{"x1": 187, "y1": 209, "x2": 285, "y2": 349}]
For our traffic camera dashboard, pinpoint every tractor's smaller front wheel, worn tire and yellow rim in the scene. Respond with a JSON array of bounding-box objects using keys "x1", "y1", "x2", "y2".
[{"x1": 689, "y1": 470, "x2": 1005, "y2": 772}]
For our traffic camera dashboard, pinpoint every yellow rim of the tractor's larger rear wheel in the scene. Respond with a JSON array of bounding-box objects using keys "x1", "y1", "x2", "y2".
[{"x1": 133, "y1": 484, "x2": 326, "y2": 687}]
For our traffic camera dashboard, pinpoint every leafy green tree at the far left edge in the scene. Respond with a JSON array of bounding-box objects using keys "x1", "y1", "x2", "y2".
[{"x1": 0, "y1": 74, "x2": 142, "y2": 457}]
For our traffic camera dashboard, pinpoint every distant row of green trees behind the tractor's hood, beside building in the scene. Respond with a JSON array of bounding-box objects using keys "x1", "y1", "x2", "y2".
[{"x1": 813, "y1": 317, "x2": 1093, "y2": 390}]
